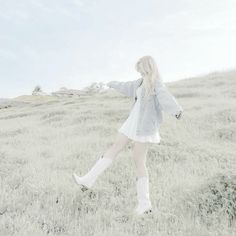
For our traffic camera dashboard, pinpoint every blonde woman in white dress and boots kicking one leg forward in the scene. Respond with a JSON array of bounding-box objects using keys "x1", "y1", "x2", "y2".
[{"x1": 73, "y1": 56, "x2": 183, "y2": 215}]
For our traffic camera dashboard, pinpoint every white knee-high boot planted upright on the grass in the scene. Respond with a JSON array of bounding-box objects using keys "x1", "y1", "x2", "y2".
[{"x1": 134, "y1": 176, "x2": 152, "y2": 215}]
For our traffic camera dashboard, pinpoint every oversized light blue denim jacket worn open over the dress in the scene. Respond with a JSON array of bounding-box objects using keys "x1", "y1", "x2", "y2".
[{"x1": 107, "y1": 78, "x2": 183, "y2": 136}]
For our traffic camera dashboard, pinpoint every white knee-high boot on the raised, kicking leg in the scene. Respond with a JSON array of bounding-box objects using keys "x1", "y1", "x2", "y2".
[{"x1": 73, "y1": 155, "x2": 113, "y2": 191}]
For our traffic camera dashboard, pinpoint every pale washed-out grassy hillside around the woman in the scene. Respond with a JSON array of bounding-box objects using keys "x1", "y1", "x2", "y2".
[{"x1": 0, "y1": 71, "x2": 236, "y2": 236}]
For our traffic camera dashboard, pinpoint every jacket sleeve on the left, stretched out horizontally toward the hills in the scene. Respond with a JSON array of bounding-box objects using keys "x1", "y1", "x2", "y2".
[{"x1": 107, "y1": 79, "x2": 139, "y2": 97}]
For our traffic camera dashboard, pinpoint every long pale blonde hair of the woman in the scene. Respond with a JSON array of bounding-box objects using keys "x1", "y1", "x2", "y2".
[{"x1": 135, "y1": 56, "x2": 163, "y2": 98}]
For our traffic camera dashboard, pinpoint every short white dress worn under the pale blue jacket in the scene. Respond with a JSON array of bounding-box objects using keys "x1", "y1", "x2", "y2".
[{"x1": 118, "y1": 83, "x2": 161, "y2": 143}]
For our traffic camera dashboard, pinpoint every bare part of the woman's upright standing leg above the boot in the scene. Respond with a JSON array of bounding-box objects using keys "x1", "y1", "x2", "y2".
[{"x1": 133, "y1": 142, "x2": 148, "y2": 177}]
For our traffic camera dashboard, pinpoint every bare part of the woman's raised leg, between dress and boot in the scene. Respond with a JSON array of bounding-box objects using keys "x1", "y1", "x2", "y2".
[{"x1": 103, "y1": 132, "x2": 130, "y2": 160}]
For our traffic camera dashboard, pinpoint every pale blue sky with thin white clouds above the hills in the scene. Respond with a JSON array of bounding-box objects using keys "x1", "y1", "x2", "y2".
[{"x1": 0, "y1": 0, "x2": 236, "y2": 98}]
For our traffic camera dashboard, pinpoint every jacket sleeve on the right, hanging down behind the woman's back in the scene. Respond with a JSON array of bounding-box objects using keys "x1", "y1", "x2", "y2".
[{"x1": 156, "y1": 84, "x2": 183, "y2": 116}]
